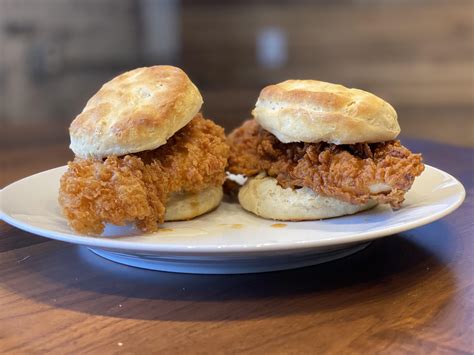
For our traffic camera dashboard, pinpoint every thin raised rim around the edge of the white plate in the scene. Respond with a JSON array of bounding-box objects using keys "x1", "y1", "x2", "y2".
[{"x1": 0, "y1": 164, "x2": 466, "y2": 255}]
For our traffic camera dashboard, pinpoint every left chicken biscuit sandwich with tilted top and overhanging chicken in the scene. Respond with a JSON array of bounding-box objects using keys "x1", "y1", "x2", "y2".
[{"x1": 59, "y1": 66, "x2": 229, "y2": 234}]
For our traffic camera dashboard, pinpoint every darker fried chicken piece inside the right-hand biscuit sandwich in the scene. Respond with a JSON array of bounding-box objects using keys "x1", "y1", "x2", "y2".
[{"x1": 228, "y1": 120, "x2": 424, "y2": 208}]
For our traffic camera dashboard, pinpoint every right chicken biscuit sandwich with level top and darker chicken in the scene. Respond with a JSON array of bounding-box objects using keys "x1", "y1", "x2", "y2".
[{"x1": 228, "y1": 80, "x2": 424, "y2": 220}]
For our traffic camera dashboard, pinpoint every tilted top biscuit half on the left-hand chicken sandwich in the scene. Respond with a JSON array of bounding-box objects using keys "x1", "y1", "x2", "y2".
[{"x1": 69, "y1": 66, "x2": 202, "y2": 159}]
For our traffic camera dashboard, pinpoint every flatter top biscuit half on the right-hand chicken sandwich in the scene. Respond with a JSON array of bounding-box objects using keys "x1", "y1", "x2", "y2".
[{"x1": 252, "y1": 80, "x2": 400, "y2": 144}]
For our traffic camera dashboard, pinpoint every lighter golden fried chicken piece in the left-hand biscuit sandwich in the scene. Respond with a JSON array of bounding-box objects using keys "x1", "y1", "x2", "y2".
[{"x1": 59, "y1": 114, "x2": 229, "y2": 234}]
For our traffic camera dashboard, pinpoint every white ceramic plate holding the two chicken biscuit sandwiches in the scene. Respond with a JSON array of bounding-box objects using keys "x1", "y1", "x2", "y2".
[{"x1": 0, "y1": 166, "x2": 465, "y2": 273}]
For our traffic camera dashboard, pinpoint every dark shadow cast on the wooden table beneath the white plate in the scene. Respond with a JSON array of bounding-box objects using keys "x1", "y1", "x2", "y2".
[{"x1": 2, "y1": 221, "x2": 460, "y2": 321}]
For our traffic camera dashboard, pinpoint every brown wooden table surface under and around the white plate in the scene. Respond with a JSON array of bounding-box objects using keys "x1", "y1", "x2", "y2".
[{"x1": 0, "y1": 141, "x2": 474, "y2": 354}]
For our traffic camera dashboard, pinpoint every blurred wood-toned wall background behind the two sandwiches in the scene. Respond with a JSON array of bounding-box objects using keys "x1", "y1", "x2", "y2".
[{"x1": 0, "y1": 0, "x2": 474, "y2": 160}]
